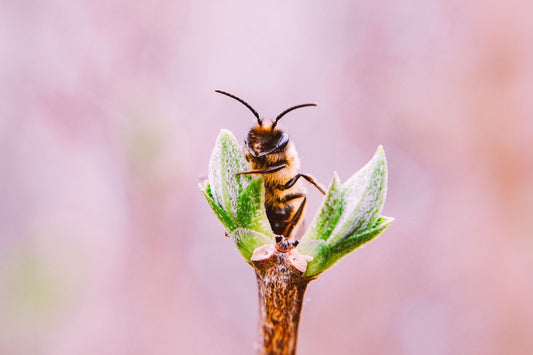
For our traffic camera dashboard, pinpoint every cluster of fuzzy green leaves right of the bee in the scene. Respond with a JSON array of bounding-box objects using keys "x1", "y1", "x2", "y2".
[{"x1": 298, "y1": 146, "x2": 393, "y2": 276}]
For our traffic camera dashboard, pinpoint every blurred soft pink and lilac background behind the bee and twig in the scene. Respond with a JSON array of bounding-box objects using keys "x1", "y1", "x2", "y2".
[{"x1": 0, "y1": 0, "x2": 533, "y2": 355}]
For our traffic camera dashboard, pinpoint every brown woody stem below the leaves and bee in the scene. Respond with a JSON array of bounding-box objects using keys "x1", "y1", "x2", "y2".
[{"x1": 253, "y1": 250, "x2": 312, "y2": 355}]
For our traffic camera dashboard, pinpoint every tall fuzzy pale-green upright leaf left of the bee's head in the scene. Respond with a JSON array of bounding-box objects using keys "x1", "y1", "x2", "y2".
[{"x1": 208, "y1": 129, "x2": 252, "y2": 219}]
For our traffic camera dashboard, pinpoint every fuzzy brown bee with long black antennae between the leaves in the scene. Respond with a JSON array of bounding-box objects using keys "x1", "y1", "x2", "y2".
[{"x1": 215, "y1": 90, "x2": 325, "y2": 241}]
